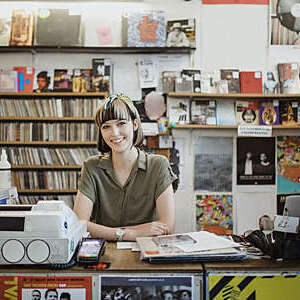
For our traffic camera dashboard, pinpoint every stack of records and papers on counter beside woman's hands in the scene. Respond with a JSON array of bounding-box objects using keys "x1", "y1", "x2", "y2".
[{"x1": 136, "y1": 231, "x2": 246, "y2": 263}]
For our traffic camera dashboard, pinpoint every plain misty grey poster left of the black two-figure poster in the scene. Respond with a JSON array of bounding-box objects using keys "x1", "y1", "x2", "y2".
[{"x1": 194, "y1": 136, "x2": 233, "y2": 192}]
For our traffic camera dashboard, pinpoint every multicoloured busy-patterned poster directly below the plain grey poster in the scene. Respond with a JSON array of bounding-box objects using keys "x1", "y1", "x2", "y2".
[{"x1": 196, "y1": 194, "x2": 233, "y2": 235}]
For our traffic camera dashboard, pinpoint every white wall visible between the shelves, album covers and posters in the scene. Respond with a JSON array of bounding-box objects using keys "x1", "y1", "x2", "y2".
[{"x1": 0, "y1": 0, "x2": 300, "y2": 233}]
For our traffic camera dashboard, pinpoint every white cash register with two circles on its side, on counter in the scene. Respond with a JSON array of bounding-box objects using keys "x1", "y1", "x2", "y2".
[{"x1": 0, "y1": 200, "x2": 87, "y2": 265}]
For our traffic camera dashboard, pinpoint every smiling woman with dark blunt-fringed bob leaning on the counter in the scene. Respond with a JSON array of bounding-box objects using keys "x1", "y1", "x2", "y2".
[{"x1": 74, "y1": 95, "x2": 177, "y2": 241}]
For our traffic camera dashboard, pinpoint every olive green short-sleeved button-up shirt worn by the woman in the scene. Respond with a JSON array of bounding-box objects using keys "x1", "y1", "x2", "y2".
[{"x1": 79, "y1": 150, "x2": 177, "y2": 227}]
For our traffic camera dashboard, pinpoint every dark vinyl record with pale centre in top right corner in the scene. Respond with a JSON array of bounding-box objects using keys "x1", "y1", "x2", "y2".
[{"x1": 277, "y1": 0, "x2": 300, "y2": 32}]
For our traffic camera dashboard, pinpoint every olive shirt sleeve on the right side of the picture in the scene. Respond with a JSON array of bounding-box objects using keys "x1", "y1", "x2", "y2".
[{"x1": 155, "y1": 156, "x2": 178, "y2": 200}]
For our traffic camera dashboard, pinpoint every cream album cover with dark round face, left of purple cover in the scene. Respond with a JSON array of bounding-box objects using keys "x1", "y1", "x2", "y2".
[{"x1": 235, "y1": 100, "x2": 259, "y2": 125}]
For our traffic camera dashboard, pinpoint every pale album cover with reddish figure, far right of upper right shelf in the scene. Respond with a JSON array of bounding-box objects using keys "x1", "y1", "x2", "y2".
[{"x1": 277, "y1": 62, "x2": 300, "y2": 94}]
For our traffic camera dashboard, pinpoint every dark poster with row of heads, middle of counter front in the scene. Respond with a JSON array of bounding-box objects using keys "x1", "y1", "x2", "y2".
[{"x1": 99, "y1": 276, "x2": 194, "y2": 300}]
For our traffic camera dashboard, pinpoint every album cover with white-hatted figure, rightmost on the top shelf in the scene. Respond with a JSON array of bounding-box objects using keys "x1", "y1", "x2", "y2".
[{"x1": 166, "y1": 19, "x2": 196, "y2": 48}]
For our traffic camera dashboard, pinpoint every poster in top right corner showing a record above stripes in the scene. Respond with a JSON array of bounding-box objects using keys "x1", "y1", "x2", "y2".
[{"x1": 270, "y1": 0, "x2": 300, "y2": 48}]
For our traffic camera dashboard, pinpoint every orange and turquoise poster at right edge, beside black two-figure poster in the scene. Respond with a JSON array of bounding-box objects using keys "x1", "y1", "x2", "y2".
[{"x1": 277, "y1": 136, "x2": 300, "y2": 194}]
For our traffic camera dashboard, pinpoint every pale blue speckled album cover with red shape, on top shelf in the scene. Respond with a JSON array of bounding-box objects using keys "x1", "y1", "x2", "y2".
[{"x1": 125, "y1": 11, "x2": 166, "y2": 47}]
